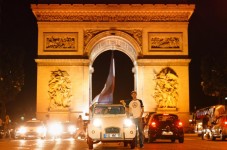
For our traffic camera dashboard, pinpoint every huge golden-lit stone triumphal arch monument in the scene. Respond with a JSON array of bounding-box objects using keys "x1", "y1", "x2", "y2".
[{"x1": 31, "y1": 4, "x2": 195, "y2": 125}]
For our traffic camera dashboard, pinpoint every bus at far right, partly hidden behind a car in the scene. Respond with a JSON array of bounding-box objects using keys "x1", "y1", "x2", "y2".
[{"x1": 194, "y1": 105, "x2": 226, "y2": 136}]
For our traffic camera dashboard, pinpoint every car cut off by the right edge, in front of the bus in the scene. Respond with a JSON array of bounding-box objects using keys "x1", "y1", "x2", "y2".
[{"x1": 210, "y1": 114, "x2": 227, "y2": 141}]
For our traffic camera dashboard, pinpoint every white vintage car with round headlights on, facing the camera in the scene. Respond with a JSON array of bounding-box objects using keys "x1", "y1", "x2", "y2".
[{"x1": 87, "y1": 104, "x2": 136, "y2": 149}]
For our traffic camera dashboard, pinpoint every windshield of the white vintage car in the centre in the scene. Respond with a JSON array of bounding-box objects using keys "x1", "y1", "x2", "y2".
[{"x1": 94, "y1": 106, "x2": 125, "y2": 114}]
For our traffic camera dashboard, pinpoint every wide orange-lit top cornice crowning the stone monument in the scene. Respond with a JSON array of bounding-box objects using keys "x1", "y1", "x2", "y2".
[{"x1": 31, "y1": 4, "x2": 195, "y2": 22}]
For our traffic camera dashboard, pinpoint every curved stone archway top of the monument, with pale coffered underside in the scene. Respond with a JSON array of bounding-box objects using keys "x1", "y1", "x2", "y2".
[{"x1": 85, "y1": 31, "x2": 141, "y2": 65}]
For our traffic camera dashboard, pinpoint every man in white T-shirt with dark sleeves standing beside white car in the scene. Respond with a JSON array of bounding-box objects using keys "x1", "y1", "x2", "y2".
[{"x1": 129, "y1": 91, "x2": 144, "y2": 148}]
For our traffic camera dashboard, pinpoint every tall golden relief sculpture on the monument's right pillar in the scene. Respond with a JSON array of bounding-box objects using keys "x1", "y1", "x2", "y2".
[{"x1": 153, "y1": 67, "x2": 178, "y2": 108}]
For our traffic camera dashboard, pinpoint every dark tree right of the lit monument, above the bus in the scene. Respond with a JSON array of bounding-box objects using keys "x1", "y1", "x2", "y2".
[{"x1": 201, "y1": 51, "x2": 227, "y2": 101}]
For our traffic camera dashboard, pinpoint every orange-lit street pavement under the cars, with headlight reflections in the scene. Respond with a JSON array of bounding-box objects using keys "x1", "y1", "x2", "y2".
[{"x1": 0, "y1": 135, "x2": 227, "y2": 150}]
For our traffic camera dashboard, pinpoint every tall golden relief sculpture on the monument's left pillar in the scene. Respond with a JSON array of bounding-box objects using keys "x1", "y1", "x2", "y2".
[{"x1": 48, "y1": 69, "x2": 72, "y2": 110}]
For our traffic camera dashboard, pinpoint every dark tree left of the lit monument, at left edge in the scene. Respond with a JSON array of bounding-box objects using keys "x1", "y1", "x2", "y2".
[{"x1": 0, "y1": 45, "x2": 24, "y2": 109}]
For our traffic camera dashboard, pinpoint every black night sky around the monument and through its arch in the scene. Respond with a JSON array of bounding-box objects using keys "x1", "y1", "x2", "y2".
[{"x1": 0, "y1": 0, "x2": 227, "y2": 119}]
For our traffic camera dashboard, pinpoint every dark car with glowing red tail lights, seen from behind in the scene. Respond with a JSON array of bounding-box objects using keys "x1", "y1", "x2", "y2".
[{"x1": 144, "y1": 113, "x2": 184, "y2": 143}]
